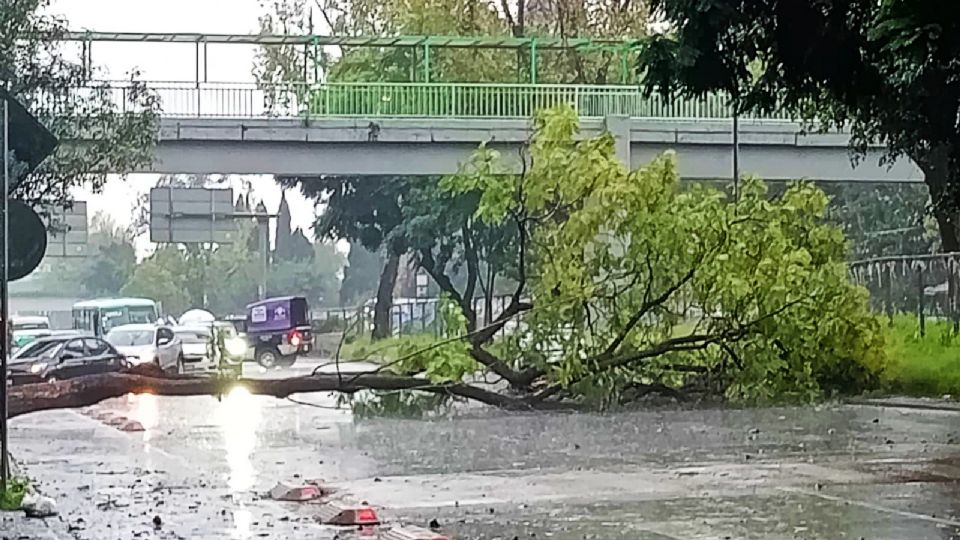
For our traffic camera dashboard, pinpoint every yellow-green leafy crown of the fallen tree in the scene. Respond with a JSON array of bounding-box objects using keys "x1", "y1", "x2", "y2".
[{"x1": 445, "y1": 110, "x2": 885, "y2": 400}]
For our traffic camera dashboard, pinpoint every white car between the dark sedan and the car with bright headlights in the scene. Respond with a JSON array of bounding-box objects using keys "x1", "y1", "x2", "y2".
[{"x1": 104, "y1": 324, "x2": 183, "y2": 373}]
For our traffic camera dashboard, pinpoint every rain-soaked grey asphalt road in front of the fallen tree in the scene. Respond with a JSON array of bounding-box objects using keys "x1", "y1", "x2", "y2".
[{"x1": 9, "y1": 356, "x2": 960, "y2": 540}]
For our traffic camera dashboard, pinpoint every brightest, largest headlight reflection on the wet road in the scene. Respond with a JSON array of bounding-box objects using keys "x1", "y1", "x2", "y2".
[{"x1": 215, "y1": 386, "x2": 260, "y2": 492}]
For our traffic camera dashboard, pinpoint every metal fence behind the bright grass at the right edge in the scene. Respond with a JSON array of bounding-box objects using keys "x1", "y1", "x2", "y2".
[{"x1": 850, "y1": 253, "x2": 960, "y2": 335}]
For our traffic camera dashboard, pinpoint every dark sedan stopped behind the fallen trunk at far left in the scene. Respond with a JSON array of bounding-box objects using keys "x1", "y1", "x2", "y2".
[{"x1": 7, "y1": 336, "x2": 129, "y2": 384}]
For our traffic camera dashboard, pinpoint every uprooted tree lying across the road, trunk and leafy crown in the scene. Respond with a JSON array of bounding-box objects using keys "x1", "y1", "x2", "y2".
[{"x1": 11, "y1": 109, "x2": 885, "y2": 414}]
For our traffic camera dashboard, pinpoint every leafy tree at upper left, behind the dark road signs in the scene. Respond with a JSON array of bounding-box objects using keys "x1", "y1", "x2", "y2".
[{"x1": 0, "y1": 0, "x2": 159, "y2": 208}]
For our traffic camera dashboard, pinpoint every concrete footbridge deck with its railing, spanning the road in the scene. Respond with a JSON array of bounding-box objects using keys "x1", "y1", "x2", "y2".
[{"x1": 94, "y1": 83, "x2": 923, "y2": 182}]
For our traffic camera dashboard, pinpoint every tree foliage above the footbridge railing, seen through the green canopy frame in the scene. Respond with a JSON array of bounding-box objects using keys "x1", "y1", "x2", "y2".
[{"x1": 255, "y1": 0, "x2": 649, "y2": 87}]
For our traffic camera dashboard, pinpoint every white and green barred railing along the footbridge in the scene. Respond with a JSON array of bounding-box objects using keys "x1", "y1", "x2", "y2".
[{"x1": 41, "y1": 82, "x2": 792, "y2": 120}]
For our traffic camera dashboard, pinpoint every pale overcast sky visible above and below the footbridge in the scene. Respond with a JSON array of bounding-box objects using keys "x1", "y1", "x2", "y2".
[{"x1": 51, "y1": 0, "x2": 314, "y2": 252}]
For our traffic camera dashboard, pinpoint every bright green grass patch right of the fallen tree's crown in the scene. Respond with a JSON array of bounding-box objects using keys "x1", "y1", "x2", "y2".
[{"x1": 883, "y1": 315, "x2": 960, "y2": 396}]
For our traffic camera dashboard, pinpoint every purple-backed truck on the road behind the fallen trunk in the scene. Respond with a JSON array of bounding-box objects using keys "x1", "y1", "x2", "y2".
[{"x1": 246, "y1": 296, "x2": 313, "y2": 368}]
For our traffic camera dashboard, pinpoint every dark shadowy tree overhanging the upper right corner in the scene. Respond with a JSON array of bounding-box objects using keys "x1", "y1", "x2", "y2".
[{"x1": 640, "y1": 0, "x2": 960, "y2": 252}]
